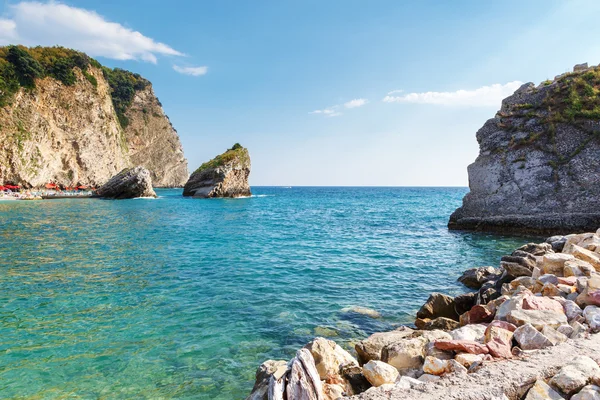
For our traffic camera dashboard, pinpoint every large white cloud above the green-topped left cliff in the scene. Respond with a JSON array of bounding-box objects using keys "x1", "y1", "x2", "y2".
[{"x1": 0, "y1": 2, "x2": 183, "y2": 63}]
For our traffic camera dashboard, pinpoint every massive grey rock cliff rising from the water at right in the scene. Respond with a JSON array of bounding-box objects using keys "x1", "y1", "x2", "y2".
[{"x1": 448, "y1": 64, "x2": 600, "y2": 233}]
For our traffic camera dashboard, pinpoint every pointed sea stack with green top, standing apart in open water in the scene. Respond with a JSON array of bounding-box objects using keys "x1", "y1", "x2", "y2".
[{"x1": 183, "y1": 143, "x2": 250, "y2": 198}]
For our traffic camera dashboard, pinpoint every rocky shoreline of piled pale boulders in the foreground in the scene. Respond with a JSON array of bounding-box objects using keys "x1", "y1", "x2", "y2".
[{"x1": 247, "y1": 230, "x2": 600, "y2": 400}]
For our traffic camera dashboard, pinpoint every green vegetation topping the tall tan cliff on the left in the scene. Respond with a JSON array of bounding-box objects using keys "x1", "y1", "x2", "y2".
[{"x1": 0, "y1": 46, "x2": 150, "y2": 128}]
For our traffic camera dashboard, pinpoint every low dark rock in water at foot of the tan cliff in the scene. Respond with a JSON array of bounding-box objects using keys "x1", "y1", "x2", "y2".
[{"x1": 96, "y1": 167, "x2": 156, "y2": 200}]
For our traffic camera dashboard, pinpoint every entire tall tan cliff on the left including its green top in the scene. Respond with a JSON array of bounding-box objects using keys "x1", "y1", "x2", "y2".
[{"x1": 0, "y1": 46, "x2": 188, "y2": 187}]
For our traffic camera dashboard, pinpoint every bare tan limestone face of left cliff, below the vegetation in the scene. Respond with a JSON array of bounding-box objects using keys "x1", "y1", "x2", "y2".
[{"x1": 0, "y1": 49, "x2": 188, "y2": 188}]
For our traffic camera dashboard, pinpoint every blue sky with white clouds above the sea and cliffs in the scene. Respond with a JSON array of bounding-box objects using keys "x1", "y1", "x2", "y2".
[{"x1": 0, "y1": 0, "x2": 600, "y2": 186}]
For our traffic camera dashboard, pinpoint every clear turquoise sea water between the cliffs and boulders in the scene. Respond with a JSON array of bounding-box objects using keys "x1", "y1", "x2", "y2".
[{"x1": 0, "y1": 187, "x2": 526, "y2": 399}]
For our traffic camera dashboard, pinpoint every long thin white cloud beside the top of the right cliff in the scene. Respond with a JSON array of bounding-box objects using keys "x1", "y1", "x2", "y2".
[{"x1": 383, "y1": 81, "x2": 523, "y2": 107}]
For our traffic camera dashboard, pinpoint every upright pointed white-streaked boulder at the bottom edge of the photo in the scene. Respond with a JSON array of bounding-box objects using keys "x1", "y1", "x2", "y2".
[{"x1": 285, "y1": 349, "x2": 324, "y2": 400}]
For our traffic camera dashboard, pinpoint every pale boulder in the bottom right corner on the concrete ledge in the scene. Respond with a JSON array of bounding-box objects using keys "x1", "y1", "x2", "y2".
[{"x1": 550, "y1": 356, "x2": 600, "y2": 394}]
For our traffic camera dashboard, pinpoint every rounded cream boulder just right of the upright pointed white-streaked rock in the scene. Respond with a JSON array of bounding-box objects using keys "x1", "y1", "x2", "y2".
[{"x1": 304, "y1": 337, "x2": 358, "y2": 383}]
